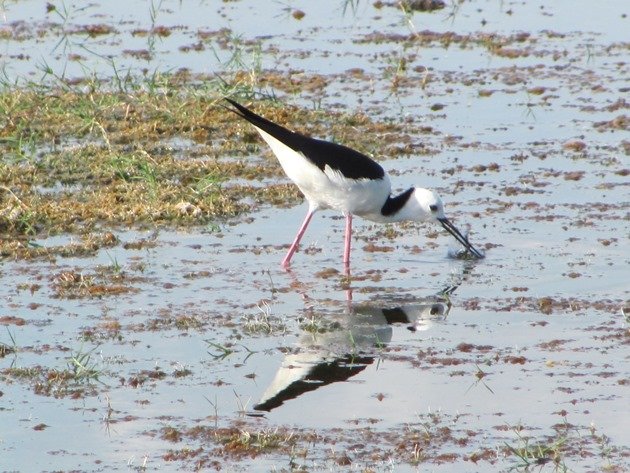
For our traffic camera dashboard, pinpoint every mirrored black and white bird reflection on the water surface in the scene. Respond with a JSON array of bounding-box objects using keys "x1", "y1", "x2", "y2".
[{"x1": 254, "y1": 296, "x2": 451, "y2": 411}]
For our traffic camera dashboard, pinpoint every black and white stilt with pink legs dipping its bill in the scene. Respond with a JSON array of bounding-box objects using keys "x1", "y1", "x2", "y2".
[{"x1": 226, "y1": 98, "x2": 484, "y2": 269}]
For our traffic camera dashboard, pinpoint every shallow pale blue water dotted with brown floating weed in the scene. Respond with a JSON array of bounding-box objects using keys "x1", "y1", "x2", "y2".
[{"x1": 0, "y1": 1, "x2": 630, "y2": 471}]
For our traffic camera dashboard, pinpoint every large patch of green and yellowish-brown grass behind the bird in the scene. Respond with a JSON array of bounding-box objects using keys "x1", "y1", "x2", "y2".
[{"x1": 0, "y1": 64, "x2": 414, "y2": 258}]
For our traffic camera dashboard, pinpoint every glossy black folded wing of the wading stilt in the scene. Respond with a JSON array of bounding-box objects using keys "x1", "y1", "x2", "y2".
[{"x1": 225, "y1": 98, "x2": 385, "y2": 179}]
